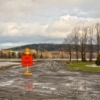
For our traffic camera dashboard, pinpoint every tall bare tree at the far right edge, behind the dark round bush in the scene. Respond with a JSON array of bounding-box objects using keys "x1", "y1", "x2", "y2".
[{"x1": 95, "y1": 23, "x2": 100, "y2": 54}]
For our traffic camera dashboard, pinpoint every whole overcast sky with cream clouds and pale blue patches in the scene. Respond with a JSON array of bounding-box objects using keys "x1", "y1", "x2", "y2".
[{"x1": 0, "y1": 0, "x2": 100, "y2": 48}]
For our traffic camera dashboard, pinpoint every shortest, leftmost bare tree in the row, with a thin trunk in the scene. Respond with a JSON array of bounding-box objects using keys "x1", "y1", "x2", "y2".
[{"x1": 63, "y1": 34, "x2": 72, "y2": 61}]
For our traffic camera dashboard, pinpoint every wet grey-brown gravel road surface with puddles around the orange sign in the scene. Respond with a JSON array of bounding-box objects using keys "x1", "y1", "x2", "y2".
[{"x1": 0, "y1": 61, "x2": 100, "y2": 100}]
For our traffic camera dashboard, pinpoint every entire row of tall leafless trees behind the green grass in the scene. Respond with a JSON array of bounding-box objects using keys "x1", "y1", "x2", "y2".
[{"x1": 64, "y1": 23, "x2": 100, "y2": 61}]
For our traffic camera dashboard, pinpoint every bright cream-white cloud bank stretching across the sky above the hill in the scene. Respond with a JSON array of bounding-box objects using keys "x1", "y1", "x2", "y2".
[{"x1": 0, "y1": 15, "x2": 100, "y2": 39}]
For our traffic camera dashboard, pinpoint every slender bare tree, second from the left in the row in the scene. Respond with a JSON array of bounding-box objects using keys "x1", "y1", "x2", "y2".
[{"x1": 72, "y1": 27, "x2": 79, "y2": 61}]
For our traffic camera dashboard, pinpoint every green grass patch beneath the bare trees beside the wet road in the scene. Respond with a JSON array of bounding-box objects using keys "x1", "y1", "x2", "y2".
[{"x1": 65, "y1": 62, "x2": 100, "y2": 72}]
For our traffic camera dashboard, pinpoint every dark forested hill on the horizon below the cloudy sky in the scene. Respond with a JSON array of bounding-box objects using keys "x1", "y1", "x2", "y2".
[{"x1": 9, "y1": 43, "x2": 97, "y2": 52}]
